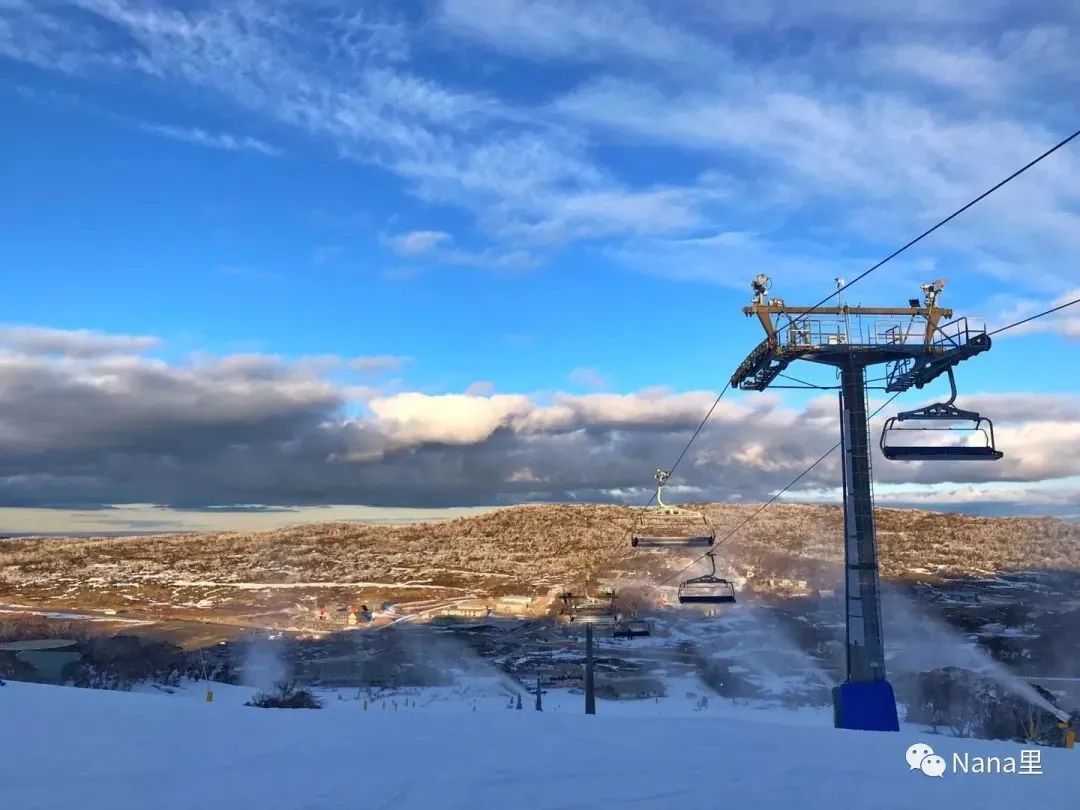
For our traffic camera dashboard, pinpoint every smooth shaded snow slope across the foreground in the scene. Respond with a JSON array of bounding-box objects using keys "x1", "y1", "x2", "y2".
[{"x1": 0, "y1": 681, "x2": 1080, "y2": 810}]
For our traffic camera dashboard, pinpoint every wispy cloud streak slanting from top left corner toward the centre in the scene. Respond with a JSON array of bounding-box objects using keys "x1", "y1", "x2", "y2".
[{"x1": 0, "y1": 0, "x2": 725, "y2": 247}]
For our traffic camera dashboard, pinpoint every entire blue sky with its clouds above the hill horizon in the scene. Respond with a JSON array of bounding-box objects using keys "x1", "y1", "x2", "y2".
[{"x1": 0, "y1": 0, "x2": 1080, "y2": 529}]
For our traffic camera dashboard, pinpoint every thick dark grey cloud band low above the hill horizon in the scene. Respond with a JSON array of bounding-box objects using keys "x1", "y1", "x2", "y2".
[{"x1": 0, "y1": 333, "x2": 1080, "y2": 508}]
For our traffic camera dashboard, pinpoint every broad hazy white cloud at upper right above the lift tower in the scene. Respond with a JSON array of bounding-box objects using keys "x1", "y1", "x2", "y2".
[{"x1": 552, "y1": 70, "x2": 1080, "y2": 292}]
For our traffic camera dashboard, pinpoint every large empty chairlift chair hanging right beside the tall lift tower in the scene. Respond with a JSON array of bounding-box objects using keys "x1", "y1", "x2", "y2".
[{"x1": 880, "y1": 368, "x2": 1004, "y2": 461}]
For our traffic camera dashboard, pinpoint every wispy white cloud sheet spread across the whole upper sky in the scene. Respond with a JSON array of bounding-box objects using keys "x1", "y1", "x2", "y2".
[{"x1": 0, "y1": 0, "x2": 1080, "y2": 336}]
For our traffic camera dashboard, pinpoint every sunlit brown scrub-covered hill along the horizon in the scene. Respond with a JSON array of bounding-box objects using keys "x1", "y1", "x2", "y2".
[{"x1": 0, "y1": 504, "x2": 1080, "y2": 626}]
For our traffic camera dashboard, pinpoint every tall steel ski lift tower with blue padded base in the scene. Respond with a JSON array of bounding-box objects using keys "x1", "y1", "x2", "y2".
[{"x1": 731, "y1": 275, "x2": 990, "y2": 731}]
